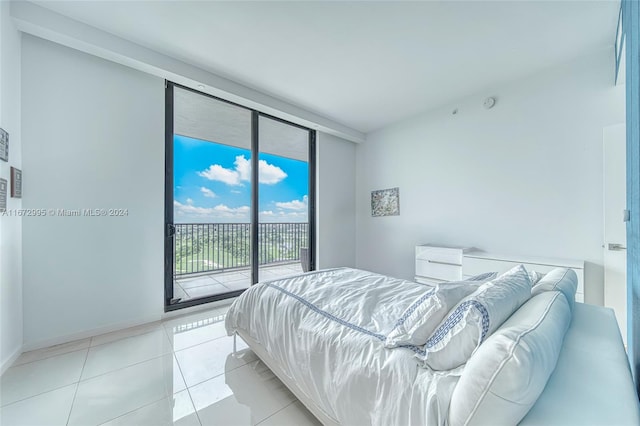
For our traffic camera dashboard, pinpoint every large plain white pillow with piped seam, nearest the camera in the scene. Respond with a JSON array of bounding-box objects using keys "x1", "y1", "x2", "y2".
[{"x1": 449, "y1": 291, "x2": 571, "y2": 426}]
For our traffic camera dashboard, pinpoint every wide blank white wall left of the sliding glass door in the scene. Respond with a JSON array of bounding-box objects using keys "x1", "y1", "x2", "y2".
[{"x1": 22, "y1": 35, "x2": 164, "y2": 349}]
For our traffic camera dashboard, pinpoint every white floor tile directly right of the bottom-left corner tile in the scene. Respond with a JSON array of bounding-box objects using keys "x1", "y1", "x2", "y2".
[{"x1": 69, "y1": 354, "x2": 184, "y2": 426}]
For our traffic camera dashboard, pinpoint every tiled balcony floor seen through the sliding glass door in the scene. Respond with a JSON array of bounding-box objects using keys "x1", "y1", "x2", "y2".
[{"x1": 173, "y1": 262, "x2": 302, "y2": 302}]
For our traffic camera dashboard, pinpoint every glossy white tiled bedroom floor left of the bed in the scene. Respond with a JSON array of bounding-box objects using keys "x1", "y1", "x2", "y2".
[{"x1": 0, "y1": 307, "x2": 320, "y2": 426}]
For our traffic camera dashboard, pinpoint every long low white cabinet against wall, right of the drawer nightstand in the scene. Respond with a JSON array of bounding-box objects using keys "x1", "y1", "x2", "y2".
[{"x1": 462, "y1": 251, "x2": 584, "y2": 302}]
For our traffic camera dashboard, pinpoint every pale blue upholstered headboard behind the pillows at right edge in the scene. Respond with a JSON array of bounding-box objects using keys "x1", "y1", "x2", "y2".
[{"x1": 520, "y1": 303, "x2": 640, "y2": 426}]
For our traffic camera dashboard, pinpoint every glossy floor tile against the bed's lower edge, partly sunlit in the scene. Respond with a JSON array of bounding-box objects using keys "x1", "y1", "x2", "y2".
[{"x1": 189, "y1": 361, "x2": 295, "y2": 426}]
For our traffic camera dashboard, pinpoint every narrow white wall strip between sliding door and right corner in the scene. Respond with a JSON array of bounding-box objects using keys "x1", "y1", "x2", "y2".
[{"x1": 316, "y1": 132, "x2": 356, "y2": 269}]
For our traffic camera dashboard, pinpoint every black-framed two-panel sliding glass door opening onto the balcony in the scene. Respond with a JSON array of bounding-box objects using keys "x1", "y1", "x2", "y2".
[{"x1": 165, "y1": 83, "x2": 315, "y2": 310}]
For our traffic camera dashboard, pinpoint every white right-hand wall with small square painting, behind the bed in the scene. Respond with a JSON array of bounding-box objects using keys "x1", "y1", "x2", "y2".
[{"x1": 356, "y1": 50, "x2": 624, "y2": 304}]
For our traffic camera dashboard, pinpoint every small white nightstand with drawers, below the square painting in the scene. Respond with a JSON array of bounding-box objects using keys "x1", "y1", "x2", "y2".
[{"x1": 415, "y1": 244, "x2": 469, "y2": 284}]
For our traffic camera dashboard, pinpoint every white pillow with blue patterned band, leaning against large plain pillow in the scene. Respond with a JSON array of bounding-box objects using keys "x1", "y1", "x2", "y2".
[{"x1": 416, "y1": 265, "x2": 531, "y2": 370}]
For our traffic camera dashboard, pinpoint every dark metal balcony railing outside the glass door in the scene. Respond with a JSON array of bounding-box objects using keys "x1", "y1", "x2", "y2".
[{"x1": 174, "y1": 223, "x2": 309, "y2": 276}]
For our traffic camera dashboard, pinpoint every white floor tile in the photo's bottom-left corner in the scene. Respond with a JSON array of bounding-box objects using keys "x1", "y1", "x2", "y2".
[{"x1": 0, "y1": 384, "x2": 77, "y2": 426}]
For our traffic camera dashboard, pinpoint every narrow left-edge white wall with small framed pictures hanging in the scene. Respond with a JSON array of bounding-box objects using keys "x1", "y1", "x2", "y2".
[{"x1": 0, "y1": 1, "x2": 22, "y2": 373}]
